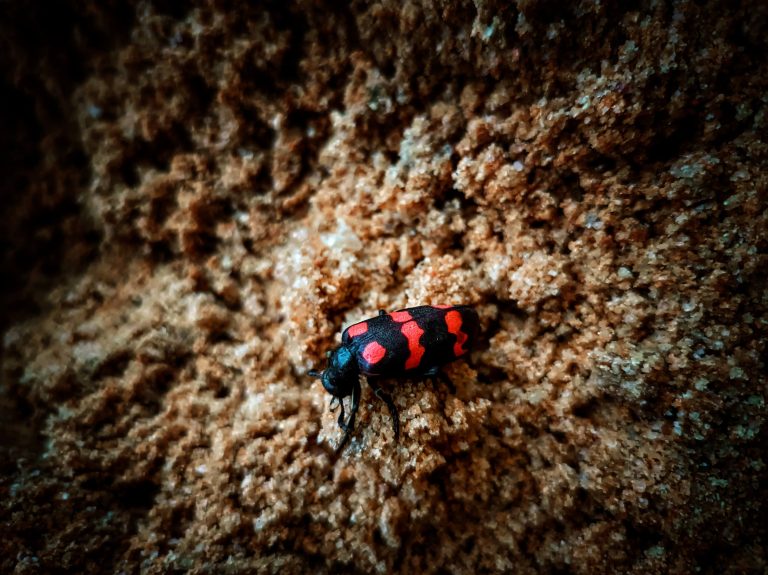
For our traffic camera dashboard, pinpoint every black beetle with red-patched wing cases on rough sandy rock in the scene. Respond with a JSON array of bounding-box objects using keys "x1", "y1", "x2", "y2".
[{"x1": 308, "y1": 305, "x2": 480, "y2": 453}]
